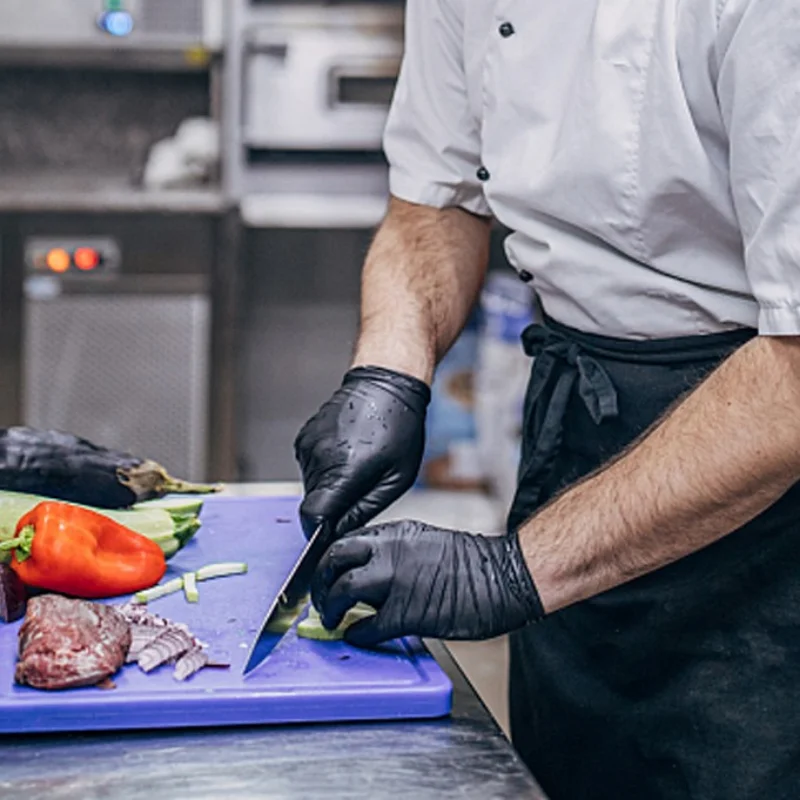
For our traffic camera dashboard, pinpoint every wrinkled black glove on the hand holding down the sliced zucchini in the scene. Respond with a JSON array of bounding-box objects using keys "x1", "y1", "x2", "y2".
[{"x1": 311, "y1": 521, "x2": 544, "y2": 647}]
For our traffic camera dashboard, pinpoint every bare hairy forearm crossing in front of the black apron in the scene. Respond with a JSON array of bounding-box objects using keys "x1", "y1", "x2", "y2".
[{"x1": 520, "y1": 337, "x2": 800, "y2": 611}]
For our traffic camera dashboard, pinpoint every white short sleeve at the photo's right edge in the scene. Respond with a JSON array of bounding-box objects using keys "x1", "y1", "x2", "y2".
[{"x1": 716, "y1": 0, "x2": 800, "y2": 336}]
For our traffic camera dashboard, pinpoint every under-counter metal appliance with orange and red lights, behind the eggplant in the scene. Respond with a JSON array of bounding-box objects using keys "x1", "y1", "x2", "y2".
[{"x1": 0, "y1": 213, "x2": 214, "y2": 480}]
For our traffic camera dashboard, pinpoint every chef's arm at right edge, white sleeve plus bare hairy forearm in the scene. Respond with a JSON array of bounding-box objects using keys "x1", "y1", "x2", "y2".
[{"x1": 521, "y1": 0, "x2": 800, "y2": 610}]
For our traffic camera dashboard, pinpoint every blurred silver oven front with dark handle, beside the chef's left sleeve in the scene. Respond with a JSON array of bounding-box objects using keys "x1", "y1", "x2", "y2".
[{"x1": 243, "y1": 7, "x2": 403, "y2": 151}]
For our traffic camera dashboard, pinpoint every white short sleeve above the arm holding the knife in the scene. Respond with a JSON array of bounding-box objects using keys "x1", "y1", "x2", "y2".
[{"x1": 384, "y1": 0, "x2": 491, "y2": 215}]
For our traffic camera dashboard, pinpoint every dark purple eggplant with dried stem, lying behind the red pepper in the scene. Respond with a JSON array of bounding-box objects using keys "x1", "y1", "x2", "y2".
[{"x1": 0, "y1": 427, "x2": 219, "y2": 508}]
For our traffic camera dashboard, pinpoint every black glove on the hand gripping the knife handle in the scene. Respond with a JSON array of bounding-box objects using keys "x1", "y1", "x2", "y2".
[{"x1": 294, "y1": 367, "x2": 431, "y2": 536}]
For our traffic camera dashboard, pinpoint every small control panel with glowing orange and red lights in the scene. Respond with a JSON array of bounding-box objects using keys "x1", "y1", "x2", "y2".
[{"x1": 25, "y1": 236, "x2": 121, "y2": 279}]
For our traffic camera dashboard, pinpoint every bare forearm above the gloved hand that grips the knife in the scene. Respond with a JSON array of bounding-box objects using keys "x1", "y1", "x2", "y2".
[{"x1": 353, "y1": 194, "x2": 490, "y2": 383}]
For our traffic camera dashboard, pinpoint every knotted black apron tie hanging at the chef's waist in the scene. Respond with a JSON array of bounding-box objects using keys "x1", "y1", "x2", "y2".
[{"x1": 520, "y1": 325, "x2": 619, "y2": 502}]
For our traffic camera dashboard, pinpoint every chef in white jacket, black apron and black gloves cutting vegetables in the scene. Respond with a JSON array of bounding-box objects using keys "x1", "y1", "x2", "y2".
[{"x1": 296, "y1": 0, "x2": 800, "y2": 800}]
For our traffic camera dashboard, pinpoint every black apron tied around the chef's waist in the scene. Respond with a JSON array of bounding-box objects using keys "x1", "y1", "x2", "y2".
[{"x1": 509, "y1": 320, "x2": 800, "y2": 800}]
